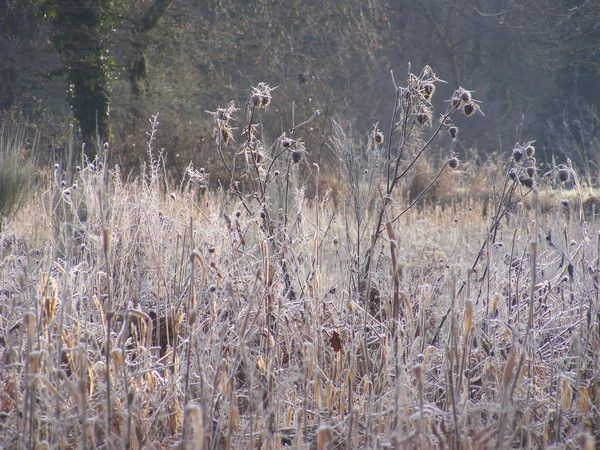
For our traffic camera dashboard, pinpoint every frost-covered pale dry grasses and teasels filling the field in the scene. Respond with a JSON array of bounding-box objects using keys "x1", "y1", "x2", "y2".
[{"x1": 0, "y1": 68, "x2": 600, "y2": 449}]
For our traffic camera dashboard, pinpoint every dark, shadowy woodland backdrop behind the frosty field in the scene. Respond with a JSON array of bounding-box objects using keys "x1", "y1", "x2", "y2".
[{"x1": 0, "y1": 0, "x2": 600, "y2": 171}]
